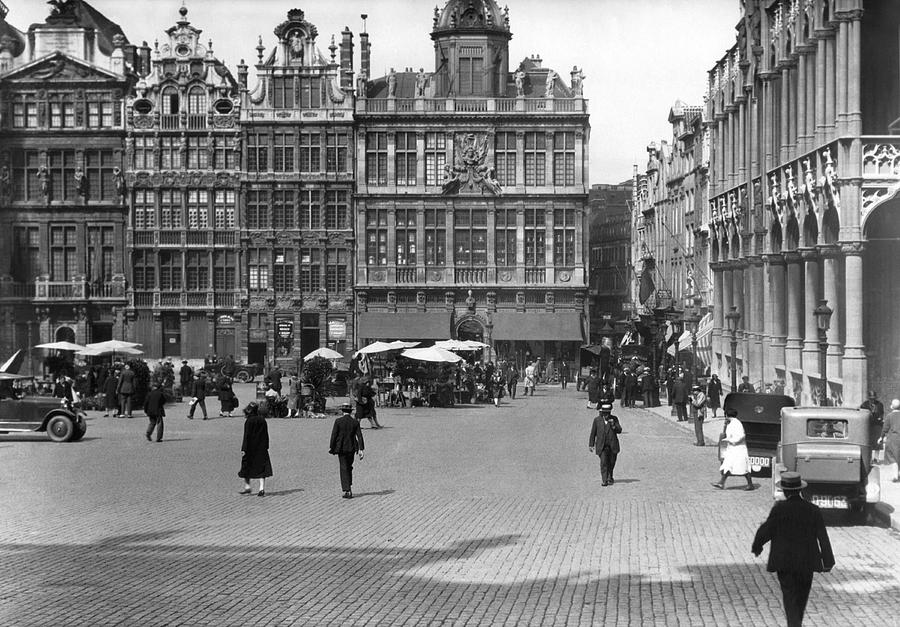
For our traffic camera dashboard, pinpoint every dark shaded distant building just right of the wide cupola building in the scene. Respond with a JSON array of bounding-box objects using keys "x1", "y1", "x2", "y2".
[{"x1": 588, "y1": 181, "x2": 634, "y2": 344}]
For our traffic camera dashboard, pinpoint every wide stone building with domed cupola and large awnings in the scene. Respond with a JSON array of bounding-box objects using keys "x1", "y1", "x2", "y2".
[{"x1": 355, "y1": 0, "x2": 590, "y2": 363}]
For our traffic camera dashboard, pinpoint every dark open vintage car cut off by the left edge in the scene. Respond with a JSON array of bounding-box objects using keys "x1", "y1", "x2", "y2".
[{"x1": 0, "y1": 378, "x2": 87, "y2": 442}]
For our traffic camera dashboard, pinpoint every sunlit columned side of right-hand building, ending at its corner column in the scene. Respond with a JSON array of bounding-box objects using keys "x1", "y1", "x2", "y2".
[{"x1": 707, "y1": 0, "x2": 866, "y2": 406}]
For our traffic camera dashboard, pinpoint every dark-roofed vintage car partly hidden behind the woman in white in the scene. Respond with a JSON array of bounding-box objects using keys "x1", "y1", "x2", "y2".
[{"x1": 719, "y1": 392, "x2": 794, "y2": 475}]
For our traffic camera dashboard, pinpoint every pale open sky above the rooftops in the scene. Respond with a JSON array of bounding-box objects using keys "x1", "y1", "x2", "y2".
[{"x1": 3, "y1": 0, "x2": 740, "y2": 184}]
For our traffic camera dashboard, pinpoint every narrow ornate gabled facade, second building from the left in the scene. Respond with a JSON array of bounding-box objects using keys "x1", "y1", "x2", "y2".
[{"x1": 125, "y1": 7, "x2": 242, "y2": 357}]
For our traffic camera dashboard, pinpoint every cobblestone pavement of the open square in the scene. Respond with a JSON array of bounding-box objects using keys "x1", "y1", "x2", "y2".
[{"x1": 0, "y1": 388, "x2": 900, "y2": 626}]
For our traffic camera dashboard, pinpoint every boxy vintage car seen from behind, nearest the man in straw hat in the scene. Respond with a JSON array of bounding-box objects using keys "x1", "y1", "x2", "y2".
[{"x1": 772, "y1": 407, "x2": 881, "y2": 512}]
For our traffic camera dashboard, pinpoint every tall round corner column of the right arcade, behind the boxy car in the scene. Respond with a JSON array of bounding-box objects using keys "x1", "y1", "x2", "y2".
[{"x1": 841, "y1": 242, "x2": 868, "y2": 407}]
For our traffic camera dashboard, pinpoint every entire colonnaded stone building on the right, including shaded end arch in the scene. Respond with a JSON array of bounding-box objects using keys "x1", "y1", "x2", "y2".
[{"x1": 708, "y1": 0, "x2": 900, "y2": 405}]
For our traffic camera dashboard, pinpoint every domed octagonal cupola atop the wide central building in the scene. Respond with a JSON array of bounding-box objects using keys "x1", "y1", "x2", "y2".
[{"x1": 431, "y1": 0, "x2": 512, "y2": 97}]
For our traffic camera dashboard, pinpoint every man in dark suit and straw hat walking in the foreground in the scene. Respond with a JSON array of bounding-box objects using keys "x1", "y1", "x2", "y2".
[{"x1": 752, "y1": 472, "x2": 834, "y2": 627}]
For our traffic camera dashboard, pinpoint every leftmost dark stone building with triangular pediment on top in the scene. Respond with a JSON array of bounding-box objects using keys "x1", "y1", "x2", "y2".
[{"x1": 0, "y1": 2, "x2": 140, "y2": 368}]
